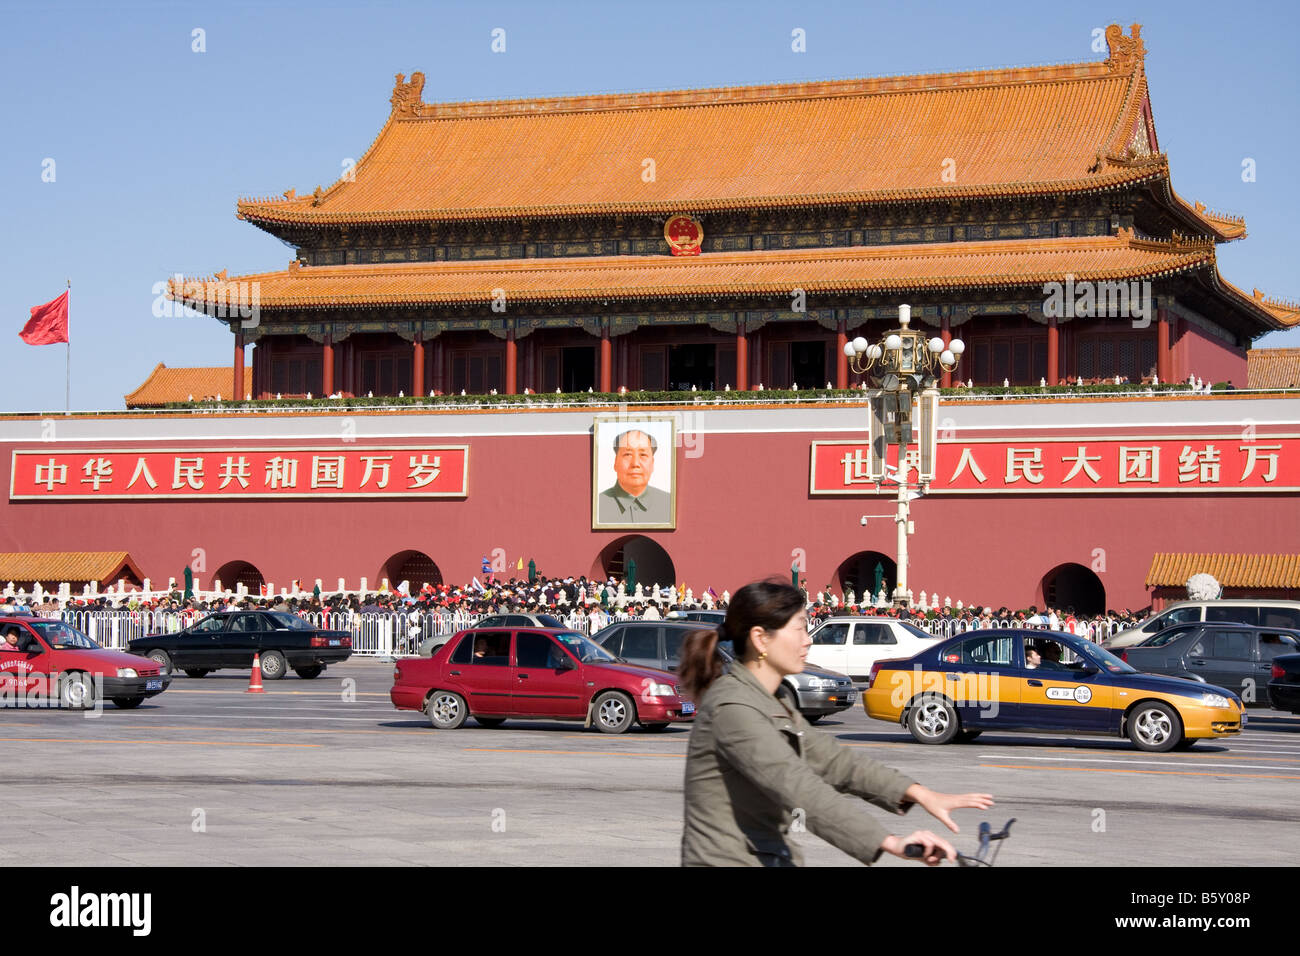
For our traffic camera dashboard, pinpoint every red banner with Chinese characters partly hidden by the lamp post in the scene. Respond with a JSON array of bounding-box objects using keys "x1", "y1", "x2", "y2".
[{"x1": 809, "y1": 434, "x2": 1300, "y2": 494}]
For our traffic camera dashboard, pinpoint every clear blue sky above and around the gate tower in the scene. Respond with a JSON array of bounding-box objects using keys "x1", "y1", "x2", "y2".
[{"x1": 0, "y1": 0, "x2": 1300, "y2": 411}]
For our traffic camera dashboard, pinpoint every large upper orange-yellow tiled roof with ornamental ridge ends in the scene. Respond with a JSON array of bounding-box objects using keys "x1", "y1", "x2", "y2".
[{"x1": 238, "y1": 25, "x2": 1244, "y2": 239}]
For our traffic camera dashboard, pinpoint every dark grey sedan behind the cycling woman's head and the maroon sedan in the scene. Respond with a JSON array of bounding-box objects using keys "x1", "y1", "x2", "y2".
[{"x1": 592, "y1": 620, "x2": 858, "y2": 723}]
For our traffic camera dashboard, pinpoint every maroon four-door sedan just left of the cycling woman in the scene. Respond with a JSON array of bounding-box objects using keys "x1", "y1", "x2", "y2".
[{"x1": 390, "y1": 628, "x2": 696, "y2": 734}]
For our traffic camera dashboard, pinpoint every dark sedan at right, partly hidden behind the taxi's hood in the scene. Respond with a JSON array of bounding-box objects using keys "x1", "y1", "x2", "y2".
[{"x1": 1118, "y1": 622, "x2": 1300, "y2": 706}]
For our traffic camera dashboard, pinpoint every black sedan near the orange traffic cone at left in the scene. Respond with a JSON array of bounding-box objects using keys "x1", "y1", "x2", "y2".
[{"x1": 129, "y1": 611, "x2": 352, "y2": 680}]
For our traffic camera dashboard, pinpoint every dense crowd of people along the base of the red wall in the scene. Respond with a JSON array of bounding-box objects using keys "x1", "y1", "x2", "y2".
[{"x1": 0, "y1": 575, "x2": 1151, "y2": 643}]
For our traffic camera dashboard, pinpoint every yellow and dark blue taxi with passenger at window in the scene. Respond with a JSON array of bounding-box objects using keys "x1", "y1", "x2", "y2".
[{"x1": 862, "y1": 628, "x2": 1245, "y2": 752}]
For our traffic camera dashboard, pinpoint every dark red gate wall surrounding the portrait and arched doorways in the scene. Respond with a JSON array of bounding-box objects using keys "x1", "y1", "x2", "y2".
[{"x1": 0, "y1": 433, "x2": 1300, "y2": 607}]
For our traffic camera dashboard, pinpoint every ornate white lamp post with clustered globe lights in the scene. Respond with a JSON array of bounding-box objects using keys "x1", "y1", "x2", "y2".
[{"x1": 844, "y1": 306, "x2": 966, "y2": 605}]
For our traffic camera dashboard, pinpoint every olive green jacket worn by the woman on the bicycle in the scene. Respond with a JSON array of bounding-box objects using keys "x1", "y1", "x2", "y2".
[{"x1": 681, "y1": 663, "x2": 915, "y2": 866}]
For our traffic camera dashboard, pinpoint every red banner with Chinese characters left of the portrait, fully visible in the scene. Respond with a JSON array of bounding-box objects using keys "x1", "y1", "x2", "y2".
[{"x1": 9, "y1": 445, "x2": 469, "y2": 501}]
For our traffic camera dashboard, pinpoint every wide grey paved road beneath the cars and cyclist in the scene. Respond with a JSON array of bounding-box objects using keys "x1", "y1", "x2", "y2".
[{"x1": 0, "y1": 661, "x2": 1300, "y2": 866}]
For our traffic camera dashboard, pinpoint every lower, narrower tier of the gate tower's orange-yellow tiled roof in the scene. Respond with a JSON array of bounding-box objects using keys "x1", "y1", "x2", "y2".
[{"x1": 169, "y1": 233, "x2": 1216, "y2": 308}]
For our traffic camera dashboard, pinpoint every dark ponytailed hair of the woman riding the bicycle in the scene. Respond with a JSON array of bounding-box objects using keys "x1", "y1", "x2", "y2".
[{"x1": 677, "y1": 578, "x2": 805, "y2": 701}]
